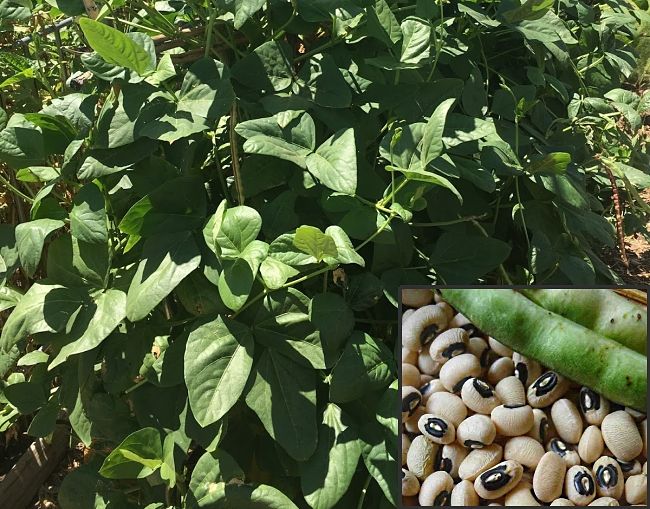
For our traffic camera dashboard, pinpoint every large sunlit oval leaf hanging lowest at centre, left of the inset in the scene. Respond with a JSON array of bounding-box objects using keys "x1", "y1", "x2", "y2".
[{"x1": 185, "y1": 317, "x2": 253, "y2": 426}]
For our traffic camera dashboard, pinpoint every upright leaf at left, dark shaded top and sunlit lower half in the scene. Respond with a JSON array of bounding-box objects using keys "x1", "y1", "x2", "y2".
[{"x1": 70, "y1": 182, "x2": 108, "y2": 244}]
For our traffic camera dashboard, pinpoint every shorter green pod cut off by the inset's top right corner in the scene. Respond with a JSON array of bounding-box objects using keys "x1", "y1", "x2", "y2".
[{"x1": 519, "y1": 288, "x2": 648, "y2": 355}]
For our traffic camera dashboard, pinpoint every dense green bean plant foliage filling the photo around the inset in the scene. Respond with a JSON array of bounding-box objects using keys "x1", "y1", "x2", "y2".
[{"x1": 0, "y1": 0, "x2": 650, "y2": 509}]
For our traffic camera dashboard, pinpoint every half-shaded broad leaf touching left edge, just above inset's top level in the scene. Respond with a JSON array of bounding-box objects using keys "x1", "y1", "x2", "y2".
[{"x1": 0, "y1": 282, "x2": 88, "y2": 351}]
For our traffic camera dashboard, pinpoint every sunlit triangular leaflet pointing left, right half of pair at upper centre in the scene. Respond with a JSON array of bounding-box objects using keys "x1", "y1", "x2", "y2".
[{"x1": 306, "y1": 129, "x2": 357, "y2": 195}]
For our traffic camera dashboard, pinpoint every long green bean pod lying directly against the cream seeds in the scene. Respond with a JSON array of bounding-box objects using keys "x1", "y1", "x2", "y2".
[{"x1": 441, "y1": 288, "x2": 647, "y2": 412}]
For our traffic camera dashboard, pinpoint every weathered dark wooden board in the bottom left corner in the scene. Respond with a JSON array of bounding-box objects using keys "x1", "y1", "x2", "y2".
[{"x1": 0, "y1": 425, "x2": 70, "y2": 509}]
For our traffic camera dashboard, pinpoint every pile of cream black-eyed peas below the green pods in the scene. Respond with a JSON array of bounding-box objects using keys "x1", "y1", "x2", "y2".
[{"x1": 401, "y1": 289, "x2": 647, "y2": 506}]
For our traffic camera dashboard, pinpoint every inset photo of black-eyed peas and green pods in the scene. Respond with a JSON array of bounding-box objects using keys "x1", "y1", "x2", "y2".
[{"x1": 400, "y1": 286, "x2": 648, "y2": 507}]
